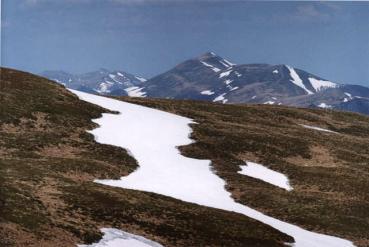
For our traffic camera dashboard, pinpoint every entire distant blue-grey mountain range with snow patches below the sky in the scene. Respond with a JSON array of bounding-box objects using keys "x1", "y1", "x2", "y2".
[{"x1": 42, "y1": 52, "x2": 369, "y2": 114}]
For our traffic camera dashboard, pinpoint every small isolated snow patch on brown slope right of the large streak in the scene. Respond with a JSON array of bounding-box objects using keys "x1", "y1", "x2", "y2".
[{"x1": 238, "y1": 161, "x2": 293, "y2": 191}]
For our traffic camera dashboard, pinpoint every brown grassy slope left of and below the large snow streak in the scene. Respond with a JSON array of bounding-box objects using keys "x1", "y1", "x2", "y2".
[{"x1": 0, "y1": 69, "x2": 291, "y2": 247}]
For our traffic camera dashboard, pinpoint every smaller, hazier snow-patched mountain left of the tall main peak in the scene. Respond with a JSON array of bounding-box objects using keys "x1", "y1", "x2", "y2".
[{"x1": 41, "y1": 69, "x2": 146, "y2": 96}]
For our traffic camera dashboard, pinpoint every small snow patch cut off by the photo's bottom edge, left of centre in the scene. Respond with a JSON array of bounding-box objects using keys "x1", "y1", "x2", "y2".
[{"x1": 78, "y1": 228, "x2": 163, "y2": 247}]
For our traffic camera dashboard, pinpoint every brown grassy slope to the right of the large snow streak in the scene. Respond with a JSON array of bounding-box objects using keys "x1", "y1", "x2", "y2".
[{"x1": 122, "y1": 95, "x2": 369, "y2": 246}]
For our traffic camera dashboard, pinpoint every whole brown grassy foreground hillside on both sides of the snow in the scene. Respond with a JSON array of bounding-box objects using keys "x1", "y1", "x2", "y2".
[{"x1": 0, "y1": 69, "x2": 369, "y2": 246}]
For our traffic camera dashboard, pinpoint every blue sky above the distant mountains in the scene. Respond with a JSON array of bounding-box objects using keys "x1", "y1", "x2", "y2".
[{"x1": 1, "y1": 0, "x2": 369, "y2": 86}]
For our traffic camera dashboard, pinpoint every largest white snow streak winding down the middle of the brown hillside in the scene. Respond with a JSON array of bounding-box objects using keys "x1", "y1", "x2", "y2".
[{"x1": 72, "y1": 91, "x2": 354, "y2": 247}]
